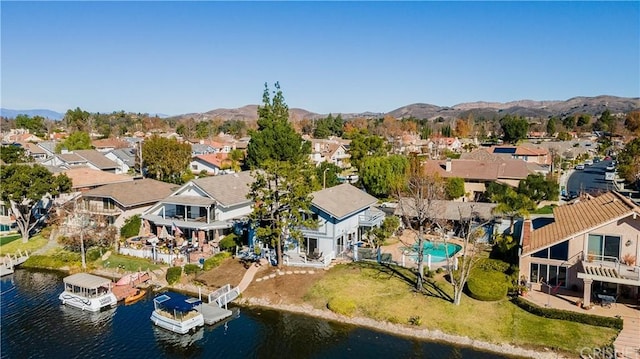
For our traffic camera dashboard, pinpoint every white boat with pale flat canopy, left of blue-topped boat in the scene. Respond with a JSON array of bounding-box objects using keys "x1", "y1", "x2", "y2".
[{"x1": 59, "y1": 273, "x2": 118, "y2": 312}]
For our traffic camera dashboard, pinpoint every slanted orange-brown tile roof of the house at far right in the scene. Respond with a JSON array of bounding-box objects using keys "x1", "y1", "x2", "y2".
[{"x1": 523, "y1": 192, "x2": 640, "y2": 253}]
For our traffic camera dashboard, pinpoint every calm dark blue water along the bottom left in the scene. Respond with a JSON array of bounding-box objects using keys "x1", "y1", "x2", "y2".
[{"x1": 0, "y1": 270, "x2": 506, "y2": 359}]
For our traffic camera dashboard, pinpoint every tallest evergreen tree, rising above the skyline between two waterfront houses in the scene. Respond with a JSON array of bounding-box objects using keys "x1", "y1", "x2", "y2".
[{"x1": 246, "y1": 82, "x2": 316, "y2": 267}]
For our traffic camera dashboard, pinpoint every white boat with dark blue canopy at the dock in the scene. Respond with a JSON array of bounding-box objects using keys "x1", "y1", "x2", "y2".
[{"x1": 151, "y1": 292, "x2": 204, "y2": 334}]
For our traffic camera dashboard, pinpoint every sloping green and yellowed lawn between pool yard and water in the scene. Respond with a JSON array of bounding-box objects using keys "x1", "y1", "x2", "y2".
[{"x1": 305, "y1": 263, "x2": 617, "y2": 355}]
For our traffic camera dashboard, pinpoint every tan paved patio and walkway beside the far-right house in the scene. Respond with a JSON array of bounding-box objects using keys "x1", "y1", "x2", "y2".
[{"x1": 525, "y1": 286, "x2": 640, "y2": 359}]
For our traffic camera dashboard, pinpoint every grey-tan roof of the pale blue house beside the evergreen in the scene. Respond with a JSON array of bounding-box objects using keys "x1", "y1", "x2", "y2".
[{"x1": 311, "y1": 183, "x2": 378, "y2": 219}]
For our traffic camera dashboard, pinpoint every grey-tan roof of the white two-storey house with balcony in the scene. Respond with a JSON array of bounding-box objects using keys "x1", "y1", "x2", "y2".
[{"x1": 192, "y1": 171, "x2": 254, "y2": 207}]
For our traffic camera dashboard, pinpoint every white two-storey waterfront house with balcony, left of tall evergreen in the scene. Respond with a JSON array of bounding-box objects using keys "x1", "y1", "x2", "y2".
[{"x1": 142, "y1": 171, "x2": 254, "y2": 248}]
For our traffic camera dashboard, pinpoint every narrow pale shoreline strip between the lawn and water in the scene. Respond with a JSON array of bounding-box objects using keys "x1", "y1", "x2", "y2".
[{"x1": 237, "y1": 298, "x2": 565, "y2": 359}]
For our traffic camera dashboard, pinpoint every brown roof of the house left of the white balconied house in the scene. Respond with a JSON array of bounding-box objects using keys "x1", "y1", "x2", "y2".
[{"x1": 82, "y1": 178, "x2": 177, "y2": 207}]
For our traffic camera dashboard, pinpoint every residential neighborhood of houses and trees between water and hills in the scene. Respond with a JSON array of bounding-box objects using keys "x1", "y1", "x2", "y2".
[{"x1": 0, "y1": 99, "x2": 640, "y2": 358}]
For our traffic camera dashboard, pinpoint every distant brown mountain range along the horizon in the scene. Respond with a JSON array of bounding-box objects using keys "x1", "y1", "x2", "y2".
[{"x1": 0, "y1": 95, "x2": 640, "y2": 121}]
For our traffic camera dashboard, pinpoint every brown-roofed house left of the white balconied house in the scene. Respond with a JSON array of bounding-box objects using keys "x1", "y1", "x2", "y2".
[{"x1": 80, "y1": 178, "x2": 176, "y2": 228}]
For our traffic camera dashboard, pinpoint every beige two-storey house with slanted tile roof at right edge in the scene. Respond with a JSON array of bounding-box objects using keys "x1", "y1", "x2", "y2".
[{"x1": 519, "y1": 192, "x2": 640, "y2": 306}]
